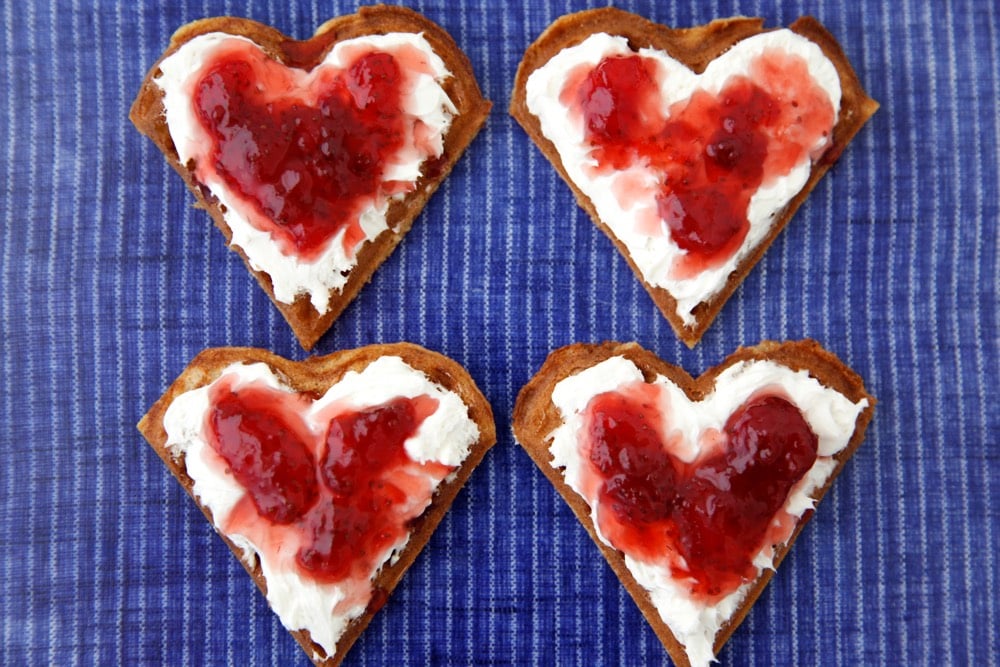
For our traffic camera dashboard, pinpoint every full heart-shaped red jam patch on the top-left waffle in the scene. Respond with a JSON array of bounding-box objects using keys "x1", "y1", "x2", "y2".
[{"x1": 193, "y1": 45, "x2": 412, "y2": 259}]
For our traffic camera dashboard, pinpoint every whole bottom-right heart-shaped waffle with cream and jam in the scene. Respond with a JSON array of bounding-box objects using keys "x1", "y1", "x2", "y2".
[{"x1": 513, "y1": 341, "x2": 875, "y2": 666}]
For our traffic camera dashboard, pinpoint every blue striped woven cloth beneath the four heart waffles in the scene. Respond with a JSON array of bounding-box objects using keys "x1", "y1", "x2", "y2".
[{"x1": 0, "y1": 0, "x2": 1000, "y2": 665}]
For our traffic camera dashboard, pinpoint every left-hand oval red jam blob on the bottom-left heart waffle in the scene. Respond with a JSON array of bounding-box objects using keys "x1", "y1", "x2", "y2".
[{"x1": 208, "y1": 386, "x2": 319, "y2": 524}]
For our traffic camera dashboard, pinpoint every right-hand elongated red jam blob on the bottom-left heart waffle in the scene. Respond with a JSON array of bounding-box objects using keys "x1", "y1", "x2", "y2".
[{"x1": 297, "y1": 398, "x2": 422, "y2": 580}]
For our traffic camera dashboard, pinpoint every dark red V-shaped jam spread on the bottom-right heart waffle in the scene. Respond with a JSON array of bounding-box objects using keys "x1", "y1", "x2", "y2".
[{"x1": 583, "y1": 383, "x2": 818, "y2": 603}]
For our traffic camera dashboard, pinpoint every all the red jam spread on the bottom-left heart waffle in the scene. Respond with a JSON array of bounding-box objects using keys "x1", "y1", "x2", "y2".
[{"x1": 205, "y1": 378, "x2": 453, "y2": 583}]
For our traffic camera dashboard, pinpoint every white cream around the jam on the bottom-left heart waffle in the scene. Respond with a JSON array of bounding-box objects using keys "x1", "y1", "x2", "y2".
[{"x1": 163, "y1": 357, "x2": 479, "y2": 656}]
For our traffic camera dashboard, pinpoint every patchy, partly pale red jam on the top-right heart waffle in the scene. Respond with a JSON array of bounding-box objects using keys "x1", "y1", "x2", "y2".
[{"x1": 562, "y1": 50, "x2": 835, "y2": 276}]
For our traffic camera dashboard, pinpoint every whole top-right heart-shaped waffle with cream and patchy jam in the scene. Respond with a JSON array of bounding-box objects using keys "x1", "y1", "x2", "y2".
[{"x1": 510, "y1": 8, "x2": 878, "y2": 346}]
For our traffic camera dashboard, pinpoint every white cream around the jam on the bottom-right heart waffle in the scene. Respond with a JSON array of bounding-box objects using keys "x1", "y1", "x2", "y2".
[{"x1": 549, "y1": 357, "x2": 868, "y2": 667}]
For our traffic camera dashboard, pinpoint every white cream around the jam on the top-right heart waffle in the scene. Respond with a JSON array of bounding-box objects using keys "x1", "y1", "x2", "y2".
[{"x1": 526, "y1": 30, "x2": 841, "y2": 325}]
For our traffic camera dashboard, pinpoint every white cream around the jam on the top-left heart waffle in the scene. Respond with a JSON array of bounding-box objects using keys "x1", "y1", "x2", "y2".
[{"x1": 153, "y1": 33, "x2": 457, "y2": 315}]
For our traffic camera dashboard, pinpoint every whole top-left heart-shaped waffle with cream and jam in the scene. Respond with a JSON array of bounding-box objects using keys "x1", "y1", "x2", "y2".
[{"x1": 130, "y1": 5, "x2": 490, "y2": 349}]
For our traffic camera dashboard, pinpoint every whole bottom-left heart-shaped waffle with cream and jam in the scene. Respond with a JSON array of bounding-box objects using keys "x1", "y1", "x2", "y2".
[{"x1": 139, "y1": 343, "x2": 496, "y2": 666}]
